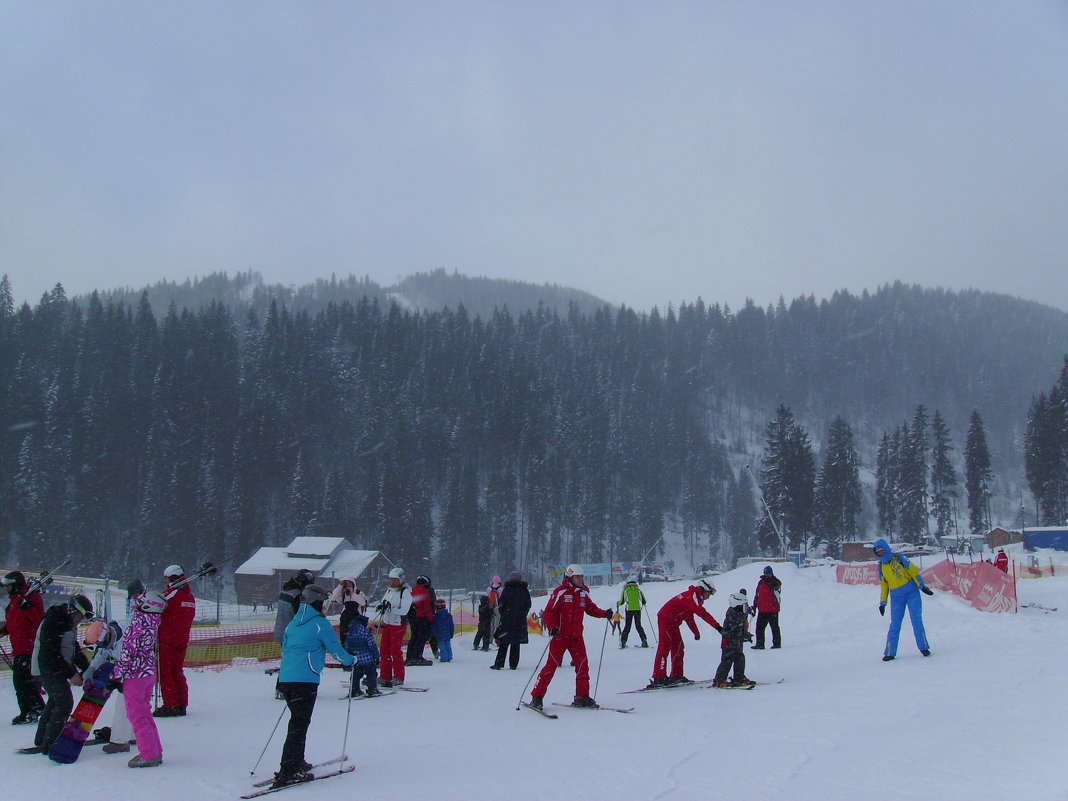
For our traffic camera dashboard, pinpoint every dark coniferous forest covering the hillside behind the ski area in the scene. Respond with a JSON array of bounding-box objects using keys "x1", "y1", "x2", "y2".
[{"x1": 0, "y1": 279, "x2": 1068, "y2": 586}]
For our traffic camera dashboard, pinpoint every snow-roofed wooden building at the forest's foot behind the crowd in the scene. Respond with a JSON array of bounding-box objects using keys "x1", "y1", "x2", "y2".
[{"x1": 234, "y1": 537, "x2": 393, "y2": 606}]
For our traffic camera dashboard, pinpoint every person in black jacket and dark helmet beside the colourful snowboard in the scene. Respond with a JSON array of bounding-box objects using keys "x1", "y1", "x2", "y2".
[{"x1": 31, "y1": 595, "x2": 93, "y2": 754}]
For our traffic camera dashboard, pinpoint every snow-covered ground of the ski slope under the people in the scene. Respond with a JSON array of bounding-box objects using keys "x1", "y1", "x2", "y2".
[{"x1": 0, "y1": 565, "x2": 1068, "y2": 801}]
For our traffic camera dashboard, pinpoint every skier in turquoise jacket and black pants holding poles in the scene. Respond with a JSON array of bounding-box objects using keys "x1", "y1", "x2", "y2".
[{"x1": 271, "y1": 584, "x2": 356, "y2": 787}]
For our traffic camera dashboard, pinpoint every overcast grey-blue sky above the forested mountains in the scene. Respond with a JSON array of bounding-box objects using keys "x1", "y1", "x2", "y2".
[{"x1": 0, "y1": 0, "x2": 1068, "y2": 310}]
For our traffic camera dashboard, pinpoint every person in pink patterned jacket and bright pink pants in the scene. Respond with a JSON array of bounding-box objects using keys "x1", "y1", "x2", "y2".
[{"x1": 111, "y1": 584, "x2": 168, "y2": 768}]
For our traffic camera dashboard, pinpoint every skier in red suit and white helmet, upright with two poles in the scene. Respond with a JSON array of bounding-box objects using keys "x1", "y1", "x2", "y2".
[{"x1": 530, "y1": 565, "x2": 612, "y2": 709}]
